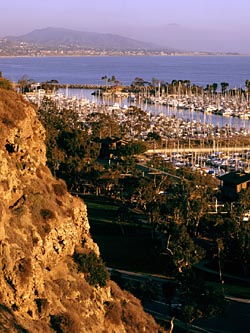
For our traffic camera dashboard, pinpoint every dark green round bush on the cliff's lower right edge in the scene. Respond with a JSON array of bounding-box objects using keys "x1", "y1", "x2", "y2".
[{"x1": 74, "y1": 251, "x2": 109, "y2": 287}]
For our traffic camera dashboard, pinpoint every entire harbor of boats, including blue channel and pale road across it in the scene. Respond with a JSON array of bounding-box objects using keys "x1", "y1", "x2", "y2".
[{"x1": 25, "y1": 89, "x2": 250, "y2": 175}]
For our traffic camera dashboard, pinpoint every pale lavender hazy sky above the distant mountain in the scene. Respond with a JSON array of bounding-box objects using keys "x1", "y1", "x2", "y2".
[{"x1": 0, "y1": 0, "x2": 250, "y2": 54}]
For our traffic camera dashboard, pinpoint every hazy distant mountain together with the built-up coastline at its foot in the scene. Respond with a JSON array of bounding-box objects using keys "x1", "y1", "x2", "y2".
[{"x1": 0, "y1": 27, "x2": 239, "y2": 56}]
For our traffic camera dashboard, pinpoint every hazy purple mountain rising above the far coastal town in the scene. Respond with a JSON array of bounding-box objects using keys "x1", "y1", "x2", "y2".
[{"x1": 6, "y1": 28, "x2": 166, "y2": 50}]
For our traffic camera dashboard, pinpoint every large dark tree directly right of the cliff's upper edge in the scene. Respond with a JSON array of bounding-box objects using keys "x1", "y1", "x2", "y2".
[{"x1": 38, "y1": 98, "x2": 100, "y2": 189}]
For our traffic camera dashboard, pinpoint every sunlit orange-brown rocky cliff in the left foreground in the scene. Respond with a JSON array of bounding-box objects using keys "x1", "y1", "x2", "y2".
[{"x1": 0, "y1": 88, "x2": 164, "y2": 333}]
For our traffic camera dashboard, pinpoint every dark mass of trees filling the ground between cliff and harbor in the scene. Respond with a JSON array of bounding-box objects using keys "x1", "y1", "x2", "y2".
[{"x1": 38, "y1": 95, "x2": 250, "y2": 322}]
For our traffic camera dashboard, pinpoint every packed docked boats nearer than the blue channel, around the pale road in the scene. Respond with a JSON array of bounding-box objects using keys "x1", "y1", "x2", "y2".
[{"x1": 23, "y1": 89, "x2": 250, "y2": 174}]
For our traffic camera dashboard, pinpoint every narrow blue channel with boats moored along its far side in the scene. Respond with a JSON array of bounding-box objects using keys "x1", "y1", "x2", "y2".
[{"x1": 56, "y1": 88, "x2": 250, "y2": 134}]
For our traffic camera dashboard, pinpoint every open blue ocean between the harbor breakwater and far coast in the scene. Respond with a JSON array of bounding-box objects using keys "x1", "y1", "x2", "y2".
[{"x1": 0, "y1": 56, "x2": 250, "y2": 90}]
